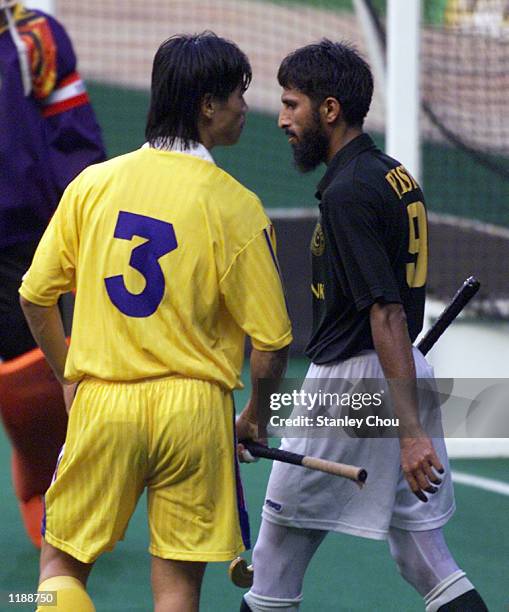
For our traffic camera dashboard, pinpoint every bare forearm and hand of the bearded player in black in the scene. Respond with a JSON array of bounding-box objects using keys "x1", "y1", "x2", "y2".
[{"x1": 370, "y1": 302, "x2": 443, "y2": 502}]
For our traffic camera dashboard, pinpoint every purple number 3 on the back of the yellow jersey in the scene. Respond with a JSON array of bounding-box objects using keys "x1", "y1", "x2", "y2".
[{"x1": 104, "y1": 211, "x2": 178, "y2": 317}]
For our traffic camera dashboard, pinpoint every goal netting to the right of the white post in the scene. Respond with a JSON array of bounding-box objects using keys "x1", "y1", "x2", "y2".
[{"x1": 369, "y1": 0, "x2": 509, "y2": 317}]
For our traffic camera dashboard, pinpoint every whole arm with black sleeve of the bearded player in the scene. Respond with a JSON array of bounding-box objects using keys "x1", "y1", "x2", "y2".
[{"x1": 322, "y1": 185, "x2": 442, "y2": 501}]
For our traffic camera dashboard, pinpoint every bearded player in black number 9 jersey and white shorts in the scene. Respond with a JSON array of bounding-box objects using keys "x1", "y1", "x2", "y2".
[{"x1": 241, "y1": 40, "x2": 486, "y2": 612}]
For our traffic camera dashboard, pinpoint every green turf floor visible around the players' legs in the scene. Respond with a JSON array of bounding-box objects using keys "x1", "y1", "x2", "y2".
[{"x1": 0, "y1": 360, "x2": 509, "y2": 612}]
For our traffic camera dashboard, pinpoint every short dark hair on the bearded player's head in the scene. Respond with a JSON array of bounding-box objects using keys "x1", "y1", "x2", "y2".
[{"x1": 277, "y1": 38, "x2": 373, "y2": 127}]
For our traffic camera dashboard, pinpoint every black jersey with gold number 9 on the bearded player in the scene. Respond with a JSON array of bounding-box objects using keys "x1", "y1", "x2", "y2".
[{"x1": 306, "y1": 134, "x2": 428, "y2": 364}]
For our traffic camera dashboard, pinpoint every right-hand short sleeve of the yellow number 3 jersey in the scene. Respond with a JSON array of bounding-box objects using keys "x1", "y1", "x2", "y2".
[{"x1": 220, "y1": 226, "x2": 292, "y2": 351}]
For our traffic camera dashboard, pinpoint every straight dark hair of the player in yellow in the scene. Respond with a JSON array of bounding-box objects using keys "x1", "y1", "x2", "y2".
[{"x1": 145, "y1": 31, "x2": 251, "y2": 147}]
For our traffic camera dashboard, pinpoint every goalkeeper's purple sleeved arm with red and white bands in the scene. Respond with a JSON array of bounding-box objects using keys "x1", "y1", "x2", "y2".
[{"x1": 24, "y1": 16, "x2": 106, "y2": 193}]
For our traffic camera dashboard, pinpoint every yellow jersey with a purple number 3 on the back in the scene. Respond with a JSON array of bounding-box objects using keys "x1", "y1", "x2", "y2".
[{"x1": 20, "y1": 147, "x2": 292, "y2": 389}]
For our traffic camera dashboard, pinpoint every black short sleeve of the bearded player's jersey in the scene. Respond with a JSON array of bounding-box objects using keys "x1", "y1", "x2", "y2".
[{"x1": 322, "y1": 184, "x2": 401, "y2": 311}]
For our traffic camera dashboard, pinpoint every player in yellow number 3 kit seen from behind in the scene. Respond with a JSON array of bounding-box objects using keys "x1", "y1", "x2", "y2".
[{"x1": 20, "y1": 32, "x2": 291, "y2": 612}]
